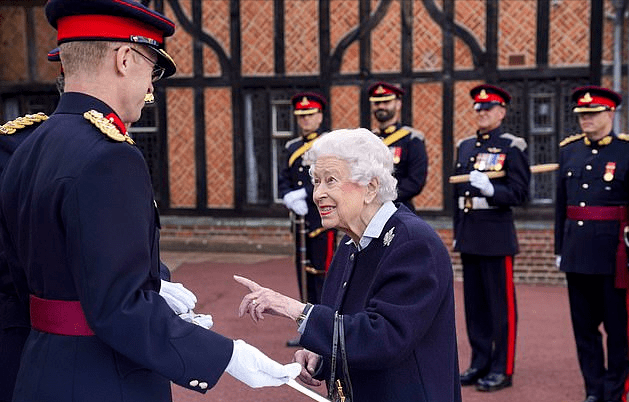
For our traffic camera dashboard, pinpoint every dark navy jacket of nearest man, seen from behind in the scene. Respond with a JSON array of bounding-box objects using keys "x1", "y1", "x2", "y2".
[{"x1": 0, "y1": 93, "x2": 233, "y2": 402}]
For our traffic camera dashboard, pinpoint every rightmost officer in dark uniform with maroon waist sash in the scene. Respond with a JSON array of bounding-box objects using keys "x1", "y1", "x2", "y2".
[{"x1": 555, "y1": 86, "x2": 629, "y2": 402}]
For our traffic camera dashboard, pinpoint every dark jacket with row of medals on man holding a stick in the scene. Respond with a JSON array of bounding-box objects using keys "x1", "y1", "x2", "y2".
[{"x1": 454, "y1": 127, "x2": 531, "y2": 256}]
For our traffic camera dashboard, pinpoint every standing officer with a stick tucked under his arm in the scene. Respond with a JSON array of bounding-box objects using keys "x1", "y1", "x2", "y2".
[{"x1": 454, "y1": 84, "x2": 531, "y2": 391}]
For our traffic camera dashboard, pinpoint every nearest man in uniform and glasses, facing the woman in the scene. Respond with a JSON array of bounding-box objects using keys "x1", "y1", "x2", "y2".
[{"x1": 0, "y1": 0, "x2": 300, "y2": 402}]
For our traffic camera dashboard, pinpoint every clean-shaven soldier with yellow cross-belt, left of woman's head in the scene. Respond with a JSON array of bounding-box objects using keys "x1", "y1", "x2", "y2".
[{"x1": 278, "y1": 92, "x2": 336, "y2": 312}]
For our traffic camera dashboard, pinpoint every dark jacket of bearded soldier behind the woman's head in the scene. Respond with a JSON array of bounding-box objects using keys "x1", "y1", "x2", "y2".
[{"x1": 375, "y1": 123, "x2": 428, "y2": 211}]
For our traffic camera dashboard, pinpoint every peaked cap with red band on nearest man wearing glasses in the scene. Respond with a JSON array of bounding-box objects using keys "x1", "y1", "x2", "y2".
[{"x1": 46, "y1": 0, "x2": 177, "y2": 77}]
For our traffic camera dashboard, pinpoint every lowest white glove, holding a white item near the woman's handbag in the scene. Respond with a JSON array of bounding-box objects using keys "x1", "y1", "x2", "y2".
[{"x1": 225, "y1": 339, "x2": 301, "y2": 388}]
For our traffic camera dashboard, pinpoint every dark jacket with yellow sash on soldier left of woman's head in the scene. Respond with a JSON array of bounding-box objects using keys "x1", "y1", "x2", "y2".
[{"x1": 278, "y1": 132, "x2": 323, "y2": 235}]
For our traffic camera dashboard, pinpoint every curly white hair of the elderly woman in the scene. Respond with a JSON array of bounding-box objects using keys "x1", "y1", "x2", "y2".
[{"x1": 304, "y1": 128, "x2": 397, "y2": 202}]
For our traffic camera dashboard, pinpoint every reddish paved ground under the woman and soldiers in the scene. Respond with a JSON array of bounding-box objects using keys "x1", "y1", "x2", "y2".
[{"x1": 162, "y1": 252, "x2": 584, "y2": 402}]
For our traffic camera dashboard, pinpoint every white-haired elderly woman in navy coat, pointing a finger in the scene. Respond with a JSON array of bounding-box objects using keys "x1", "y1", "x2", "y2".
[{"x1": 235, "y1": 128, "x2": 461, "y2": 402}]
